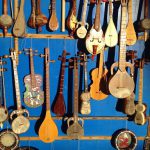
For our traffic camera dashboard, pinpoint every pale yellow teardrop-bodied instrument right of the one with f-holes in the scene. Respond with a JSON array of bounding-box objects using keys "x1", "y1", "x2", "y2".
[{"x1": 105, "y1": 0, "x2": 118, "y2": 47}]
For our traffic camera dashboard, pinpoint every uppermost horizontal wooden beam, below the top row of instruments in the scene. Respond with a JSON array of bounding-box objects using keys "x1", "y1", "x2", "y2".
[{"x1": 0, "y1": 33, "x2": 148, "y2": 40}]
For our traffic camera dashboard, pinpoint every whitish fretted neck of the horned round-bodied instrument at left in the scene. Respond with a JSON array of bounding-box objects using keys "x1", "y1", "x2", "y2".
[{"x1": 12, "y1": 60, "x2": 22, "y2": 110}]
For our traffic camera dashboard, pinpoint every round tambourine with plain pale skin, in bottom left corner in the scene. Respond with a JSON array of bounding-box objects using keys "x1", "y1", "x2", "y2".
[{"x1": 0, "y1": 129, "x2": 19, "y2": 150}]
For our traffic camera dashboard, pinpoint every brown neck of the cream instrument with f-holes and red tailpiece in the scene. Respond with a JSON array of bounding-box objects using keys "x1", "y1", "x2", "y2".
[{"x1": 94, "y1": 0, "x2": 101, "y2": 31}]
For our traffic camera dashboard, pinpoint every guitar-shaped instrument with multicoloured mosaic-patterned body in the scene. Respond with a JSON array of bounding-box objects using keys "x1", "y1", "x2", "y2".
[{"x1": 24, "y1": 48, "x2": 44, "y2": 108}]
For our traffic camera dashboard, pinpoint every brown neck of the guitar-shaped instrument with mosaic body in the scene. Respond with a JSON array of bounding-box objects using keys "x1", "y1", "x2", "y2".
[{"x1": 29, "y1": 49, "x2": 35, "y2": 87}]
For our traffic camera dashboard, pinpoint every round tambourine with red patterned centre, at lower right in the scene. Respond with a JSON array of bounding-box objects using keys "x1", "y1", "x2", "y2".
[{"x1": 114, "y1": 129, "x2": 137, "y2": 150}]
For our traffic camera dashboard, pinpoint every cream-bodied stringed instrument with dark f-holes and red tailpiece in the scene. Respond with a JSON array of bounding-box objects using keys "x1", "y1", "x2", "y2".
[{"x1": 85, "y1": 0, "x2": 105, "y2": 55}]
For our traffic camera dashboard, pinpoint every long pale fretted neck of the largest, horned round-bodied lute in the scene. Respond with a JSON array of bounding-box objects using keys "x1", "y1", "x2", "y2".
[{"x1": 119, "y1": 5, "x2": 127, "y2": 71}]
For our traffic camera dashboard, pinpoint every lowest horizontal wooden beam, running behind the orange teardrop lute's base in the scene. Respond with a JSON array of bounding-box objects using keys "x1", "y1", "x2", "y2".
[{"x1": 20, "y1": 136, "x2": 145, "y2": 141}]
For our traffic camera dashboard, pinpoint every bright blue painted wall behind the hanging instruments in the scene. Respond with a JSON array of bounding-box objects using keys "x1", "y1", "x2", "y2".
[{"x1": 0, "y1": 0, "x2": 150, "y2": 150}]
